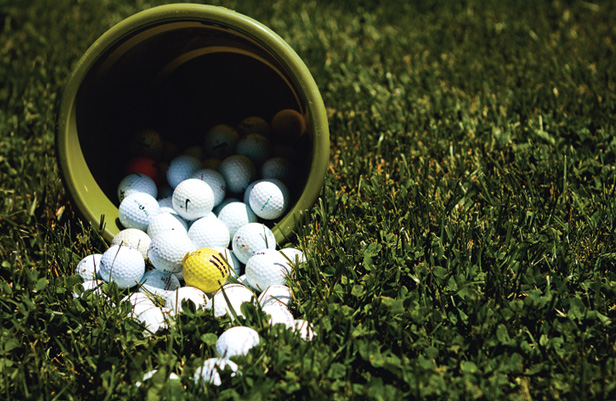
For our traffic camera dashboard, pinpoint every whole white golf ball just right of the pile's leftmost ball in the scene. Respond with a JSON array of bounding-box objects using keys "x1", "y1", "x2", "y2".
[{"x1": 100, "y1": 245, "x2": 145, "y2": 288}]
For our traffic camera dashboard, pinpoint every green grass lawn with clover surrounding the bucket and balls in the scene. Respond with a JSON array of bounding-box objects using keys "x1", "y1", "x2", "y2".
[{"x1": 0, "y1": 0, "x2": 616, "y2": 400}]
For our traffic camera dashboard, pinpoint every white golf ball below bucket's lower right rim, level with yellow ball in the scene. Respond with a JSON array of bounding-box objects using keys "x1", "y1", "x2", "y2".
[{"x1": 246, "y1": 249, "x2": 289, "y2": 291}]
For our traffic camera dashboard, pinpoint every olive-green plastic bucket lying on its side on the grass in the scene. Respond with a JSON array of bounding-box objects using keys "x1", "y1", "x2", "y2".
[{"x1": 56, "y1": 4, "x2": 329, "y2": 241}]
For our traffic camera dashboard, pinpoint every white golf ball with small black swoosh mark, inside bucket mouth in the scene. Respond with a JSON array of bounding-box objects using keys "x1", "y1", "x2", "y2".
[{"x1": 172, "y1": 178, "x2": 214, "y2": 220}]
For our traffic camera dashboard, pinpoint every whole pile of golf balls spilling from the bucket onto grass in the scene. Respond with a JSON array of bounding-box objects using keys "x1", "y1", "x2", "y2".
[{"x1": 75, "y1": 110, "x2": 315, "y2": 385}]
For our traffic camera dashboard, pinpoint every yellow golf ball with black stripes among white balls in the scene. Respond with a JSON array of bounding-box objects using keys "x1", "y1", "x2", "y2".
[{"x1": 182, "y1": 248, "x2": 229, "y2": 292}]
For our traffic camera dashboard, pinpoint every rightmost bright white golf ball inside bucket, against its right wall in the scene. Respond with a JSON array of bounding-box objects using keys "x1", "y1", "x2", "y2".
[{"x1": 249, "y1": 178, "x2": 289, "y2": 220}]
